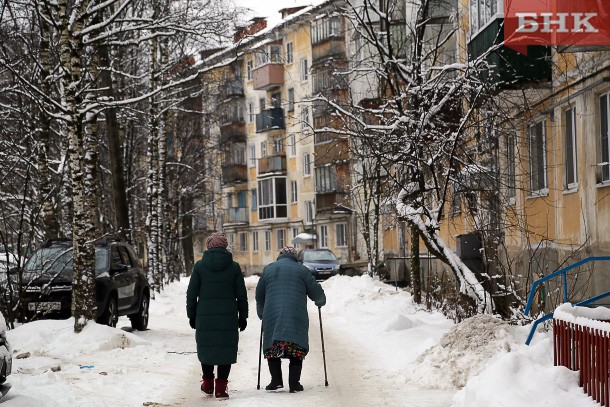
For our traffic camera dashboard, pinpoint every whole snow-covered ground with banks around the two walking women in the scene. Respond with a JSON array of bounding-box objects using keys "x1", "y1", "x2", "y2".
[{"x1": 2, "y1": 276, "x2": 597, "y2": 407}]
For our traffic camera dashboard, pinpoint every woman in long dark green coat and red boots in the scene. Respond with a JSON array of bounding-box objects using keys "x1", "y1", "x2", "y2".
[{"x1": 186, "y1": 233, "x2": 248, "y2": 398}]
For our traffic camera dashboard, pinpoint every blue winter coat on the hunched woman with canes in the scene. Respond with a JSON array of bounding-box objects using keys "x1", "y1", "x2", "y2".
[{"x1": 256, "y1": 253, "x2": 326, "y2": 350}]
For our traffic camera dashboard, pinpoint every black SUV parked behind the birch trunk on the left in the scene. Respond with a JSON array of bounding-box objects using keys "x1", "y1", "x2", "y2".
[{"x1": 22, "y1": 236, "x2": 150, "y2": 331}]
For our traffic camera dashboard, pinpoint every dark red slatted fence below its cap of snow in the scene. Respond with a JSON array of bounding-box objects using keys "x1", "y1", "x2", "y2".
[{"x1": 553, "y1": 319, "x2": 610, "y2": 406}]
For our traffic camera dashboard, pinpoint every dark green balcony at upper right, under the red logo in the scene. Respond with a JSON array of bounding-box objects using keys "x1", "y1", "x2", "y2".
[{"x1": 468, "y1": 18, "x2": 551, "y2": 89}]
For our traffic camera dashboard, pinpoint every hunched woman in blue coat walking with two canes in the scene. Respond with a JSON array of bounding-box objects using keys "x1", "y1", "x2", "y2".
[{"x1": 256, "y1": 246, "x2": 326, "y2": 393}]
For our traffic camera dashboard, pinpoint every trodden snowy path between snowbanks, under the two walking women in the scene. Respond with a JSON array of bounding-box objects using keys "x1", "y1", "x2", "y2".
[{"x1": 164, "y1": 289, "x2": 453, "y2": 407}]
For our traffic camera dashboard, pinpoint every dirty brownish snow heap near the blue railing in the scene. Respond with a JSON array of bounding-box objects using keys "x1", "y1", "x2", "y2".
[{"x1": 407, "y1": 315, "x2": 515, "y2": 389}]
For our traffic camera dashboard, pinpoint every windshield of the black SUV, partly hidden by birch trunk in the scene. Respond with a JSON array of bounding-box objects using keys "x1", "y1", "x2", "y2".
[{"x1": 24, "y1": 246, "x2": 108, "y2": 277}]
